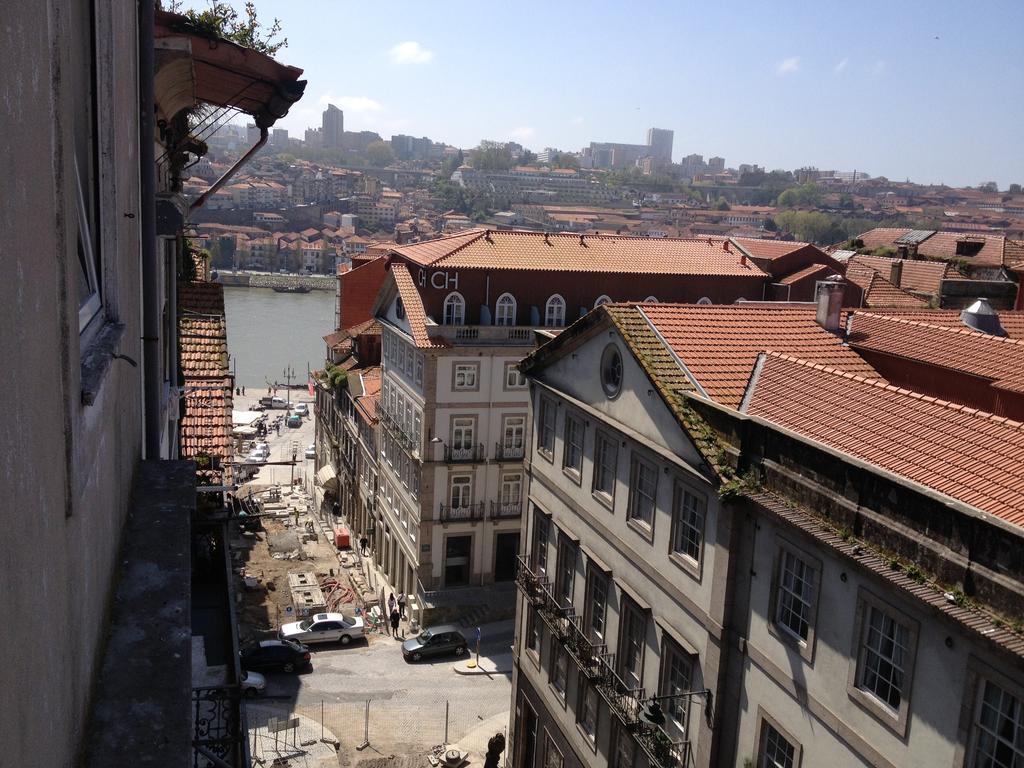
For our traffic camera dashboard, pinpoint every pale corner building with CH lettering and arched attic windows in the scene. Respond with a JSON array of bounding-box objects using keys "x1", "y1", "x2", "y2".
[{"x1": 352, "y1": 229, "x2": 782, "y2": 618}]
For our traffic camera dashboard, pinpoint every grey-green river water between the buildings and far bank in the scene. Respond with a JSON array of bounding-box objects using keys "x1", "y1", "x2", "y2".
[{"x1": 224, "y1": 286, "x2": 335, "y2": 392}]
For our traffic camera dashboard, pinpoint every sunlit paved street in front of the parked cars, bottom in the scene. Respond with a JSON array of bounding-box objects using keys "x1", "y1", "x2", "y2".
[{"x1": 249, "y1": 622, "x2": 512, "y2": 765}]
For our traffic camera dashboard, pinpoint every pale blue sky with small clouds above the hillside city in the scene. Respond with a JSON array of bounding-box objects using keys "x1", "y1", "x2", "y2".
[{"x1": 191, "y1": 0, "x2": 1024, "y2": 188}]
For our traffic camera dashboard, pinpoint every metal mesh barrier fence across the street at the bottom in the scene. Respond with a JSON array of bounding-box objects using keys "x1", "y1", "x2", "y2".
[{"x1": 247, "y1": 690, "x2": 507, "y2": 768}]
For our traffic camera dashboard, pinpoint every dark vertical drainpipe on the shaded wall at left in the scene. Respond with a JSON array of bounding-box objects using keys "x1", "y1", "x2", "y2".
[{"x1": 138, "y1": 0, "x2": 159, "y2": 460}]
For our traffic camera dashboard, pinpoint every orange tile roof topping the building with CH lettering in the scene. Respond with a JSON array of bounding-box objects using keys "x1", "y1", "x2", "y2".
[{"x1": 391, "y1": 229, "x2": 765, "y2": 279}]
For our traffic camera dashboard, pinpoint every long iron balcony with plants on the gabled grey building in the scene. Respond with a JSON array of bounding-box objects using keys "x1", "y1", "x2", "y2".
[{"x1": 516, "y1": 555, "x2": 693, "y2": 768}]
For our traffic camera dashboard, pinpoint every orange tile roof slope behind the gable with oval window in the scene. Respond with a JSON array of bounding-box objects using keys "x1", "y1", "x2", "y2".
[{"x1": 638, "y1": 302, "x2": 881, "y2": 408}]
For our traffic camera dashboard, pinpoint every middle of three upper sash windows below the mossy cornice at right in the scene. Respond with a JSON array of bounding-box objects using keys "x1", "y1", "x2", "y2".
[{"x1": 857, "y1": 603, "x2": 910, "y2": 711}]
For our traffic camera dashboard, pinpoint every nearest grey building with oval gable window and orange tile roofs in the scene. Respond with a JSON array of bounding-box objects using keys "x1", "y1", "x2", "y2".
[{"x1": 510, "y1": 286, "x2": 1024, "y2": 768}]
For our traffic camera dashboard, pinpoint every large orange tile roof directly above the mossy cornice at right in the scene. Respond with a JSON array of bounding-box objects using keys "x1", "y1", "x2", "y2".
[{"x1": 744, "y1": 354, "x2": 1024, "y2": 525}]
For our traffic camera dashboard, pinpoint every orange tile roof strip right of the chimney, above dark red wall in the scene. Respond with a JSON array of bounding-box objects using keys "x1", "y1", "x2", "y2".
[{"x1": 848, "y1": 312, "x2": 1024, "y2": 389}]
